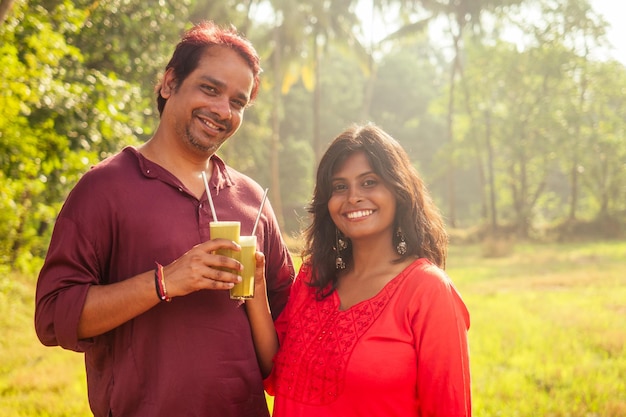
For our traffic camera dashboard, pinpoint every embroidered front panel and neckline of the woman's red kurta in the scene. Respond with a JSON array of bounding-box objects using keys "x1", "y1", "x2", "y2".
[{"x1": 274, "y1": 261, "x2": 412, "y2": 405}]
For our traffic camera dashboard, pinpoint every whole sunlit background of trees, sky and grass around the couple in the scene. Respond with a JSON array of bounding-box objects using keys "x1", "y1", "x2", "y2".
[{"x1": 0, "y1": 0, "x2": 626, "y2": 417}]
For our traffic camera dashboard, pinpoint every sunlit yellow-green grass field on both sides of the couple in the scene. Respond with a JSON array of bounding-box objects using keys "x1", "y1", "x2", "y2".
[{"x1": 0, "y1": 242, "x2": 626, "y2": 417}]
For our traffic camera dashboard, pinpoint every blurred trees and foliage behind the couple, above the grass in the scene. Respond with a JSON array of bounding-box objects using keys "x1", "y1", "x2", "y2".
[{"x1": 0, "y1": 0, "x2": 626, "y2": 272}]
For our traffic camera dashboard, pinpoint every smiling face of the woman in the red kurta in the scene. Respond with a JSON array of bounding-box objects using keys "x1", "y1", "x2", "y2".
[{"x1": 328, "y1": 152, "x2": 396, "y2": 242}]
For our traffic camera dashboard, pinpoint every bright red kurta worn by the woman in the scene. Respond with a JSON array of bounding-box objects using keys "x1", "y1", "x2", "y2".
[{"x1": 265, "y1": 259, "x2": 471, "y2": 417}]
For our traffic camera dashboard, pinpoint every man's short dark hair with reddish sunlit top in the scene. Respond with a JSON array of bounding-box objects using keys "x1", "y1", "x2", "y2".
[{"x1": 154, "y1": 21, "x2": 262, "y2": 115}]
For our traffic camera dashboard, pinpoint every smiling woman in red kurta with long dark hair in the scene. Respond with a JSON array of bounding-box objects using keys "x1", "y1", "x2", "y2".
[{"x1": 247, "y1": 124, "x2": 471, "y2": 417}]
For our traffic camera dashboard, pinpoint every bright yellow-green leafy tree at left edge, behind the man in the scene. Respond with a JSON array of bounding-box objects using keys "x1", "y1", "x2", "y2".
[{"x1": 0, "y1": 0, "x2": 153, "y2": 268}]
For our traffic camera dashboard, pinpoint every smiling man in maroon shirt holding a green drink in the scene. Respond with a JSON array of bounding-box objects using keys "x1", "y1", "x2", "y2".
[{"x1": 35, "y1": 23, "x2": 294, "y2": 417}]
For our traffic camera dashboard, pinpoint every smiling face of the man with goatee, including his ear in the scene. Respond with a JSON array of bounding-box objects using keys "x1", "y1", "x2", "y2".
[{"x1": 161, "y1": 46, "x2": 254, "y2": 156}]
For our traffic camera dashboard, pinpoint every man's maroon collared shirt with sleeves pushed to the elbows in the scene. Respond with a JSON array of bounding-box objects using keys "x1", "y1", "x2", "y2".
[{"x1": 35, "y1": 147, "x2": 294, "y2": 417}]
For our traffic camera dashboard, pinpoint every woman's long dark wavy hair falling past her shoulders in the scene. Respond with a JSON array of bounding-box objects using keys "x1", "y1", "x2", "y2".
[{"x1": 302, "y1": 123, "x2": 448, "y2": 298}]
